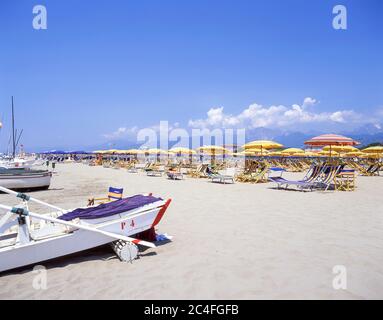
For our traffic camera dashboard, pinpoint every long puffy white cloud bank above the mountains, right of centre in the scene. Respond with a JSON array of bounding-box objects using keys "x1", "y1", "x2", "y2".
[{"x1": 189, "y1": 97, "x2": 359, "y2": 129}]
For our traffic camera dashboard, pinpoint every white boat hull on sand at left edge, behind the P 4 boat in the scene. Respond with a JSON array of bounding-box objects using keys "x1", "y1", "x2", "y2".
[{"x1": 0, "y1": 168, "x2": 52, "y2": 190}]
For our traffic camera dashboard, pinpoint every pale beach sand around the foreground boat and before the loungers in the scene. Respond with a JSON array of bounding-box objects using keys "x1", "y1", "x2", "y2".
[{"x1": 0, "y1": 164, "x2": 383, "y2": 299}]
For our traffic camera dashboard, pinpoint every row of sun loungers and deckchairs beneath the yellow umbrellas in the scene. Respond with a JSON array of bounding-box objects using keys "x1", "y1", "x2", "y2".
[{"x1": 86, "y1": 159, "x2": 383, "y2": 191}]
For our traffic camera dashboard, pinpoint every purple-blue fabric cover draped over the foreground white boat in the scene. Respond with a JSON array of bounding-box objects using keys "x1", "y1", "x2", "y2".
[{"x1": 59, "y1": 194, "x2": 162, "y2": 221}]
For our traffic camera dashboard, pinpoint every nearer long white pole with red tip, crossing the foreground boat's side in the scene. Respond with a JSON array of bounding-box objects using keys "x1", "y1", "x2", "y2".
[{"x1": 0, "y1": 204, "x2": 156, "y2": 248}]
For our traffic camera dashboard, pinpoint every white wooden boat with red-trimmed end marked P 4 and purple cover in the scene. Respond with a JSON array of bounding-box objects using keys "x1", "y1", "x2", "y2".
[{"x1": 0, "y1": 187, "x2": 171, "y2": 272}]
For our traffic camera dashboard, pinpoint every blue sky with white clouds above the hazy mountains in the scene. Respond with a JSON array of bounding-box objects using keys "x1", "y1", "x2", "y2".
[{"x1": 0, "y1": 0, "x2": 383, "y2": 150}]
